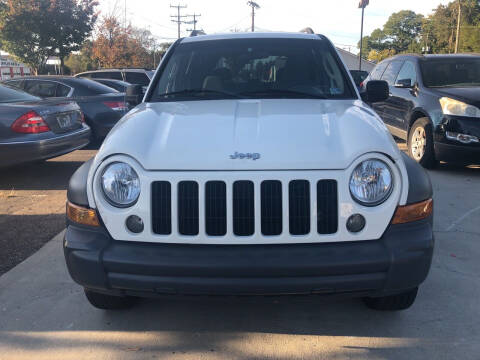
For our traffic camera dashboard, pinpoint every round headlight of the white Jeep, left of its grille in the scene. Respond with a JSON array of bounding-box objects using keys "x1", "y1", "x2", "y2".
[{"x1": 102, "y1": 162, "x2": 140, "y2": 208}]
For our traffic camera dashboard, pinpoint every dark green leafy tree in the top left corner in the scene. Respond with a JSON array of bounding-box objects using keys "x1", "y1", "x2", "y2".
[{"x1": 0, "y1": 0, "x2": 97, "y2": 72}]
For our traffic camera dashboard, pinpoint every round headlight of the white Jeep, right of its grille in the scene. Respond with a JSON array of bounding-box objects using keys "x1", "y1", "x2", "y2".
[{"x1": 350, "y1": 159, "x2": 393, "y2": 206}]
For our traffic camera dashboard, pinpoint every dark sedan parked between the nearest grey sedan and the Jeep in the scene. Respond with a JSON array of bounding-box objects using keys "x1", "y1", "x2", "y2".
[{"x1": 5, "y1": 76, "x2": 128, "y2": 138}]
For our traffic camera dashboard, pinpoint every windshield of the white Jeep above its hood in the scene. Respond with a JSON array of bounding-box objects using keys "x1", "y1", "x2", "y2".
[{"x1": 150, "y1": 39, "x2": 354, "y2": 101}]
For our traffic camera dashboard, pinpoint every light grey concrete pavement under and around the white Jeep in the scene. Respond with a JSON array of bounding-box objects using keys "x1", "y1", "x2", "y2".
[{"x1": 0, "y1": 160, "x2": 480, "y2": 360}]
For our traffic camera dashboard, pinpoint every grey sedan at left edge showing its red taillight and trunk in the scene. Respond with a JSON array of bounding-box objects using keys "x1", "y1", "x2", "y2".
[{"x1": 0, "y1": 85, "x2": 90, "y2": 166}]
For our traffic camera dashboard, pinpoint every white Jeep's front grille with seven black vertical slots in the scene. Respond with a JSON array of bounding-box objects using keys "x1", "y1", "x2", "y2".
[{"x1": 152, "y1": 179, "x2": 338, "y2": 237}]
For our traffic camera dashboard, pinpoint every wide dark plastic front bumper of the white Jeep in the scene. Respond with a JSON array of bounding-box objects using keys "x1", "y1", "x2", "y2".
[{"x1": 64, "y1": 218, "x2": 434, "y2": 296}]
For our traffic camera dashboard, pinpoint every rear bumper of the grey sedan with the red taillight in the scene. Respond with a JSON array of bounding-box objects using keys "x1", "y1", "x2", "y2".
[{"x1": 0, "y1": 126, "x2": 90, "y2": 166}]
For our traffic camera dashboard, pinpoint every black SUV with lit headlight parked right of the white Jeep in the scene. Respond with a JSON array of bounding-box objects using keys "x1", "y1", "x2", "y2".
[{"x1": 364, "y1": 55, "x2": 480, "y2": 168}]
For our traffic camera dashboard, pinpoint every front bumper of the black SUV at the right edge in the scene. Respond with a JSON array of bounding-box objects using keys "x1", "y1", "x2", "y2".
[{"x1": 434, "y1": 115, "x2": 480, "y2": 164}]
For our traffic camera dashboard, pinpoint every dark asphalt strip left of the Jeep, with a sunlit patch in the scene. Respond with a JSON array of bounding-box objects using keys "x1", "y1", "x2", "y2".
[{"x1": 0, "y1": 149, "x2": 96, "y2": 275}]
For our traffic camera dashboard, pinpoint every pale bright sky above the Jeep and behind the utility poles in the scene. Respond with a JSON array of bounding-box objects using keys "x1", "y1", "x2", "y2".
[{"x1": 99, "y1": 0, "x2": 452, "y2": 51}]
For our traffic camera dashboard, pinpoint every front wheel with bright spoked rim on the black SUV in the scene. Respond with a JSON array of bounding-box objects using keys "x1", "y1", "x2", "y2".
[{"x1": 408, "y1": 118, "x2": 437, "y2": 169}]
